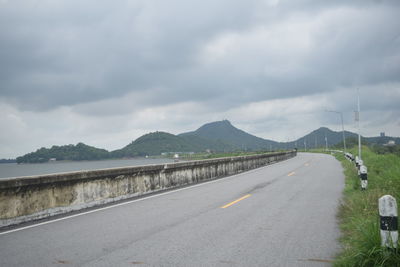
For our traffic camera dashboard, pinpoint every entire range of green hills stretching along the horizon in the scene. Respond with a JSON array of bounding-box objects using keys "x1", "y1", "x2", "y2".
[{"x1": 17, "y1": 120, "x2": 400, "y2": 163}]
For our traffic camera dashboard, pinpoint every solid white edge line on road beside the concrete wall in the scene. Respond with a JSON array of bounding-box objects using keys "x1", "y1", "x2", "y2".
[{"x1": 0, "y1": 158, "x2": 290, "y2": 236}]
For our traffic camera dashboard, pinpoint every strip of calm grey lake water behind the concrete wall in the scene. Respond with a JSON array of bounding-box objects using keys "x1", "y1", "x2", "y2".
[{"x1": 0, "y1": 158, "x2": 174, "y2": 179}]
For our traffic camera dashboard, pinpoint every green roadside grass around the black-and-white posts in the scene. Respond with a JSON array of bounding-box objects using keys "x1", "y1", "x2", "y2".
[{"x1": 333, "y1": 147, "x2": 400, "y2": 267}]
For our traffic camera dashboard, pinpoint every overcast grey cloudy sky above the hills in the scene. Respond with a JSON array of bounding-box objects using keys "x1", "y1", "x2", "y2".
[{"x1": 0, "y1": 0, "x2": 400, "y2": 158}]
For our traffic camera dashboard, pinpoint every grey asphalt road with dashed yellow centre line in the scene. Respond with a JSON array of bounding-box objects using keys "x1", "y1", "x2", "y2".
[{"x1": 0, "y1": 153, "x2": 344, "y2": 266}]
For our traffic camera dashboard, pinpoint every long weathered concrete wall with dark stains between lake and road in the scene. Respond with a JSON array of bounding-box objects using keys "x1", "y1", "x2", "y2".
[{"x1": 0, "y1": 151, "x2": 296, "y2": 227}]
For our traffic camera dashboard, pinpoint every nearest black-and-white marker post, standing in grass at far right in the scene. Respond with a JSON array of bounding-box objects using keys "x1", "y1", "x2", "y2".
[{"x1": 379, "y1": 195, "x2": 399, "y2": 248}]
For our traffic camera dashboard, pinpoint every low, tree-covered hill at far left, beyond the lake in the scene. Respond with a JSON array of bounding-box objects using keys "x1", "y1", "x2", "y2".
[{"x1": 17, "y1": 143, "x2": 110, "y2": 163}]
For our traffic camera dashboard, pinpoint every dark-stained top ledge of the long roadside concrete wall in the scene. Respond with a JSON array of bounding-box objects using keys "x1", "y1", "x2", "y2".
[{"x1": 0, "y1": 152, "x2": 290, "y2": 190}]
